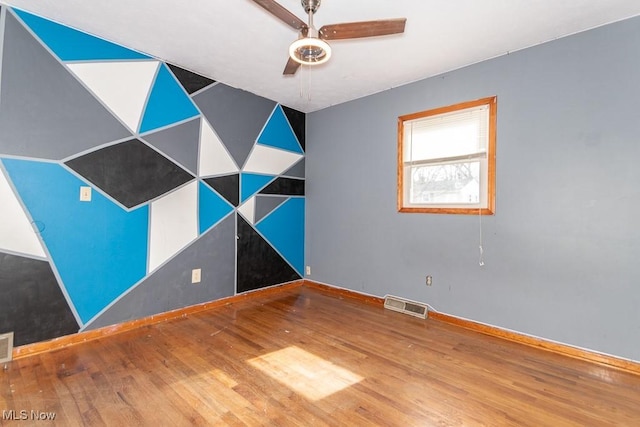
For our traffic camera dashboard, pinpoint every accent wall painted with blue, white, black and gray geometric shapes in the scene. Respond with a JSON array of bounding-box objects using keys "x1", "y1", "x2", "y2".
[{"x1": 0, "y1": 6, "x2": 305, "y2": 345}]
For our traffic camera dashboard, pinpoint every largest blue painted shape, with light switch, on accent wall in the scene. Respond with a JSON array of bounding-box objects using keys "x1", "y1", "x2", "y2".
[{"x1": 2, "y1": 159, "x2": 149, "y2": 324}]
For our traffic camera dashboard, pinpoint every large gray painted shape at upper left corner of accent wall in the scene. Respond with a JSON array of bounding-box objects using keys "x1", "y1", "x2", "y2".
[{"x1": 0, "y1": 13, "x2": 131, "y2": 160}]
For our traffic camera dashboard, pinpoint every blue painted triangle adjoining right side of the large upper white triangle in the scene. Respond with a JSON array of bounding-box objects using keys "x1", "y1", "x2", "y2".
[{"x1": 140, "y1": 64, "x2": 200, "y2": 133}]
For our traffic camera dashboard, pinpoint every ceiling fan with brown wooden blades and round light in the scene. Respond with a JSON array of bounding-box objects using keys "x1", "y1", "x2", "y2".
[{"x1": 253, "y1": 0, "x2": 407, "y2": 75}]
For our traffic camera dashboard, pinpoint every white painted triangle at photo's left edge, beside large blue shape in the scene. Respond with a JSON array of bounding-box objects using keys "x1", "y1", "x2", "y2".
[{"x1": 0, "y1": 171, "x2": 46, "y2": 258}]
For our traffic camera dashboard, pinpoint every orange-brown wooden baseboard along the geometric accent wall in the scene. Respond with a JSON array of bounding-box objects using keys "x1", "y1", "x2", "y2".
[{"x1": 12, "y1": 280, "x2": 303, "y2": 360}]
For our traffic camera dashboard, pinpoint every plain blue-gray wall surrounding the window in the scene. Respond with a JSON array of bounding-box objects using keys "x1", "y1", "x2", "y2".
[{"x1": 306, "y1": 18, "x2": 640, "y2": 360}]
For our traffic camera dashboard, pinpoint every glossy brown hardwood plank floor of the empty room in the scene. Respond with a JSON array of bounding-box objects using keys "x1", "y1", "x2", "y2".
[{"x1": 0, "y1": 286, "x2": 640, "y2": 426}]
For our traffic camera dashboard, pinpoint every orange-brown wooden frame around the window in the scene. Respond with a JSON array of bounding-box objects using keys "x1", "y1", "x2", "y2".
[{"x1": 397, "y1": 96, "x2": 497, "y2": 215}]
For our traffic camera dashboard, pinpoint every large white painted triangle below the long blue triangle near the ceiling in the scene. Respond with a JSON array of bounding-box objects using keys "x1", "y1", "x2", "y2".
[{"x1": 67, "y1": 61, "x2": 158, "y2": 133}]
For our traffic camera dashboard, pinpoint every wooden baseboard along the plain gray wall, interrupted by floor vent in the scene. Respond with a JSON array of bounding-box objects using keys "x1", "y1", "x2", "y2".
[{"x1": 304, "y1": 280, "x2": 640, "y2": 375}]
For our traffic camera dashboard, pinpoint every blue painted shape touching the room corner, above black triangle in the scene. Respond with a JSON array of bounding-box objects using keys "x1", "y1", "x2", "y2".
[{"x1": 256, "y1": 197, "x2": 304, "y2": 276}]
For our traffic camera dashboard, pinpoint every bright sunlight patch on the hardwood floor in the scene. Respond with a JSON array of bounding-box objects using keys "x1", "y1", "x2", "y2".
[{"x1": 247, "y1": 346, "x2": 364, "y2": 401}]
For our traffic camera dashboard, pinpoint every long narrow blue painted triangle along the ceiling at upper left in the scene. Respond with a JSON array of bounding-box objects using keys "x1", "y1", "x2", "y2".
[{"x1": 13, "y1": 9, "x2": 149, "y2": 61}]
